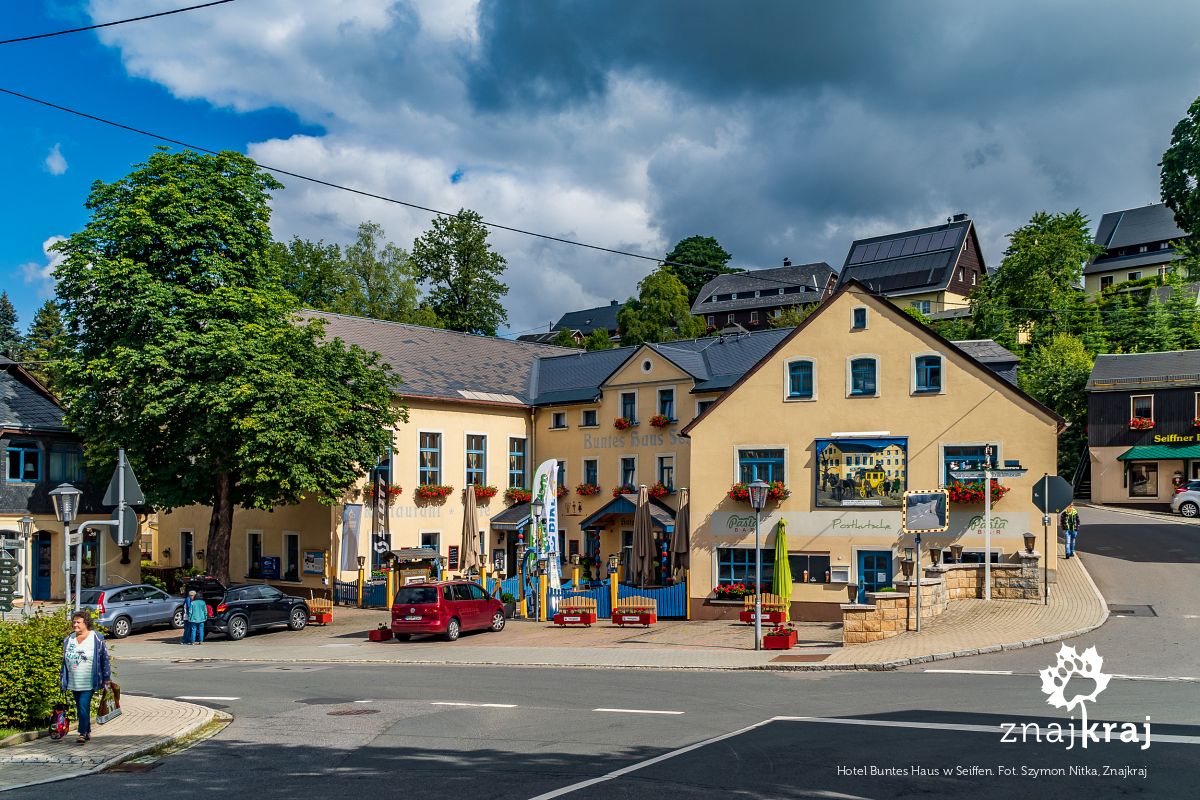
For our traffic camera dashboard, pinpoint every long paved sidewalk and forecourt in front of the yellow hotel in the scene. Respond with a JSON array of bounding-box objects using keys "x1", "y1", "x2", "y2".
[{"x1": 114, "y1": 544, "x2": 1108, "y2": 669}]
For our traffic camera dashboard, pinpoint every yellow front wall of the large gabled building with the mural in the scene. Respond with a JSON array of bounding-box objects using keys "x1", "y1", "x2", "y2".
[{"x1": 688, "y1": 290, "x2": 1058, "y2": 619}]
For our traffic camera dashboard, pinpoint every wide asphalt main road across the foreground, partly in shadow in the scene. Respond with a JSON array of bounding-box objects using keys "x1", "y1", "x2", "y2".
[{"x1": 7, "y1": 661, "x2": 1200, "y2": 800}]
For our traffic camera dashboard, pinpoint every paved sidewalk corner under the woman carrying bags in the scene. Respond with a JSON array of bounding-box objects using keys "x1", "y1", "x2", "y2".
[{"x1": 0, "y1": 694, "x2": 216, "y2": 792}]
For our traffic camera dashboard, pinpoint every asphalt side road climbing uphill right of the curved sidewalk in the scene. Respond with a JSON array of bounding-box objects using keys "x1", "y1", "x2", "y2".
[{"x1": 913, "y1": 509, "x2": 1200, "y2": 693}]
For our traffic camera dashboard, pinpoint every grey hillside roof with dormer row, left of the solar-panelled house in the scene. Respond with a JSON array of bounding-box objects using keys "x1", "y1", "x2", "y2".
[{"x1": 691, "y1": 261, "x2": 838, "y2": 315}]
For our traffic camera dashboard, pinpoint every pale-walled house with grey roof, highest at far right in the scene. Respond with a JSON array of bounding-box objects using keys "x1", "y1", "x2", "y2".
[{"x1": 1084, "y1": 203, "x2": 1187, "y2": 296}]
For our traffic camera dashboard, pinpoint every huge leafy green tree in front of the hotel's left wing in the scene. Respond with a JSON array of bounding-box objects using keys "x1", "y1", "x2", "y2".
[{"x1": 55, "y1": 150, "x2": 407, "y2": 579}]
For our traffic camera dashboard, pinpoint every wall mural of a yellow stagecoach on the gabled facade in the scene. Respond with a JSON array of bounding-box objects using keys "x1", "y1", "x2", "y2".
[{"x1": 816, "y1": 437, "x2": 908, "y2": 509}]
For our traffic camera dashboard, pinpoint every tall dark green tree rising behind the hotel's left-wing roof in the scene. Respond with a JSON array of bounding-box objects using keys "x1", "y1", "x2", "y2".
[{"x1": 412, "y1": 209, "x2": 509, "y2": 336}]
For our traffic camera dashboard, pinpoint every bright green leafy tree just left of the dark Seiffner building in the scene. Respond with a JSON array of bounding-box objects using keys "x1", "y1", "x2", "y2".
[{"x1": 1018, "y1": 333, "x2": 1092, "y2": 475}]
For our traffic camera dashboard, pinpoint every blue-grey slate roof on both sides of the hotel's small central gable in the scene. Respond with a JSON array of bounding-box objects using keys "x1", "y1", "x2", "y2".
[{"x1": 530, "y1": 327, "x2": 792, "y2": 405}]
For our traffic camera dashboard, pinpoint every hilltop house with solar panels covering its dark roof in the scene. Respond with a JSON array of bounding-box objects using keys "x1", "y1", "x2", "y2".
[{"x1": 838, "y1": 213, "x2": 988, "y2": 317}]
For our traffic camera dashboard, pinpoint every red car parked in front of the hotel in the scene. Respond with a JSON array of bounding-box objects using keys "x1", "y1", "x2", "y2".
[{"x1": 391, "y1": 581, "x2": 504, "y2": 642}]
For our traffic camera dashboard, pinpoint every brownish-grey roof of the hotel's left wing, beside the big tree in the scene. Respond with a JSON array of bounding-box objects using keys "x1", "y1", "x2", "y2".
[{"x1": 301, "y1": 311, "x2": 574, "y2": 404}]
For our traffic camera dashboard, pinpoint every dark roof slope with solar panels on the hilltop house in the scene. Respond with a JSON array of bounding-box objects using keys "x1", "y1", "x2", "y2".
[{"x1": 838, "y1": 219, "x2": 972, "y2": 295}]
